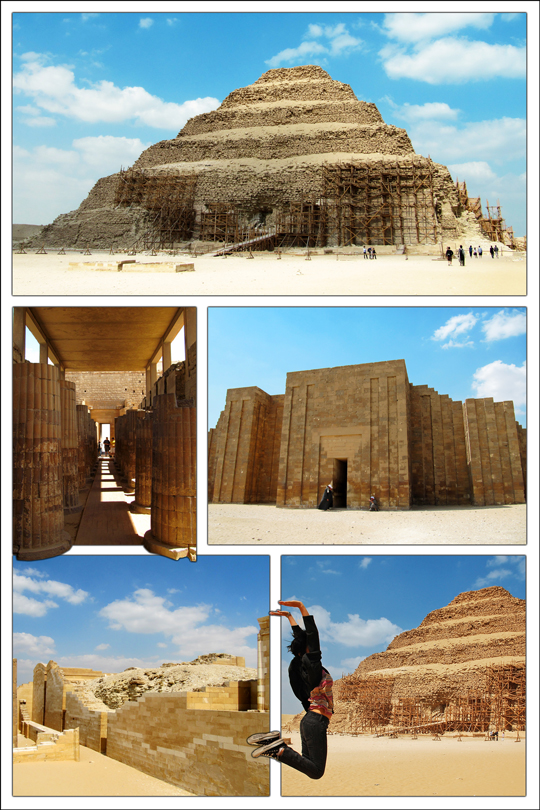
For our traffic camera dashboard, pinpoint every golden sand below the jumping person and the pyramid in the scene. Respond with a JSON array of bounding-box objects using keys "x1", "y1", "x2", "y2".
[{"x1": 280, "y1": 732, "x2": 526, "y2": 796}]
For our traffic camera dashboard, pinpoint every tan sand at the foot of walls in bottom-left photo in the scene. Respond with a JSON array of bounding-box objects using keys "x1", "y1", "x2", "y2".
[{"x1": 13, "y1": 735, "x2": 194, "y2": 796}]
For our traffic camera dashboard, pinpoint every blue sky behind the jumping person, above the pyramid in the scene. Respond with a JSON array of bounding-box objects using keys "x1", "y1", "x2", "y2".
[{"x1": 280, "y1": 554, "x2": 526, "y2": 714}]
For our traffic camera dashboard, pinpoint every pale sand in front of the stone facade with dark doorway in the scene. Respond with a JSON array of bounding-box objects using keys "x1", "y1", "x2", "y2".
[{"x1": 208, "y1": 504, "x2": 527, "y2": 546}]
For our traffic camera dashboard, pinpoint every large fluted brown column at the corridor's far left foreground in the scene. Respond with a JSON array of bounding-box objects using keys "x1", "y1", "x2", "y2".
[{"x1": 13, "y1": 363, "x2": 73, "y2": 560}]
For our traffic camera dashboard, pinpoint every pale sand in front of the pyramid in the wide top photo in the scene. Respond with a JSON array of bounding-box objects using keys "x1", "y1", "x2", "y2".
[{"x1": 13, "y1": 249, "x2": 527, "y2": 296}]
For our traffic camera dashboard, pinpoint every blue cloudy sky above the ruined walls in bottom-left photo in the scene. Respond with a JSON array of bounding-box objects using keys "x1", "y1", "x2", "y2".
[{"x1": 13, "y1": 555, "x2": 270, "y2": 683}]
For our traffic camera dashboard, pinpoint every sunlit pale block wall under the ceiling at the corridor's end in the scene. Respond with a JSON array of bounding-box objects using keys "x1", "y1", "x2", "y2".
[{"x1": 65, "y1": 369, "x2": 146, "y2": 408}]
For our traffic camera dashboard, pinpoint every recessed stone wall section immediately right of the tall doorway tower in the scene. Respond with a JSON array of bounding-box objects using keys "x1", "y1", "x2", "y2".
[{"x1": 410, "y1": 385, "x2": 471, "y2": 506}]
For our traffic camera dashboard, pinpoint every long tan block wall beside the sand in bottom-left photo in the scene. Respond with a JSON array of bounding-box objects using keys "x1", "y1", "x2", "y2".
[{"x1": 107, "y1": 693, "x2": 269, "y2": 796}]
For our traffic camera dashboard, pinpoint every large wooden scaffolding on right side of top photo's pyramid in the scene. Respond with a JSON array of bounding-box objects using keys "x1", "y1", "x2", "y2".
[{"x1": 323, "y1": 159, "x2": 438, "y2": 245}]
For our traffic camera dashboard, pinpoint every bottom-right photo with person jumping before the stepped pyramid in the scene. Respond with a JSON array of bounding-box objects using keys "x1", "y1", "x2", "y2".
[{"x1": 276, "y1": 553, "x2": 524, "y2": 799}]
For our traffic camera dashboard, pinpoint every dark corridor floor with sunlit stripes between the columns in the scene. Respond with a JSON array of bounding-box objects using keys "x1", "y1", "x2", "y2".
[{"x1": 73, "y1": 455, "x2": 150, "y2": 546}]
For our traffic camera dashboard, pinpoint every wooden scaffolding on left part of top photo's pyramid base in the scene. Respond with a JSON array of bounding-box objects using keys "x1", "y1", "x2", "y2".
[{"x1": 114, "y1": 169, "x2": 197, "y2": 250}]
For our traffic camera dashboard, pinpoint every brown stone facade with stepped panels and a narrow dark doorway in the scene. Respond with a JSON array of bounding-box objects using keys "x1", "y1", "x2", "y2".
[{"x1": 208, "y1": 360, "x2": 526, "y2": 509}]
